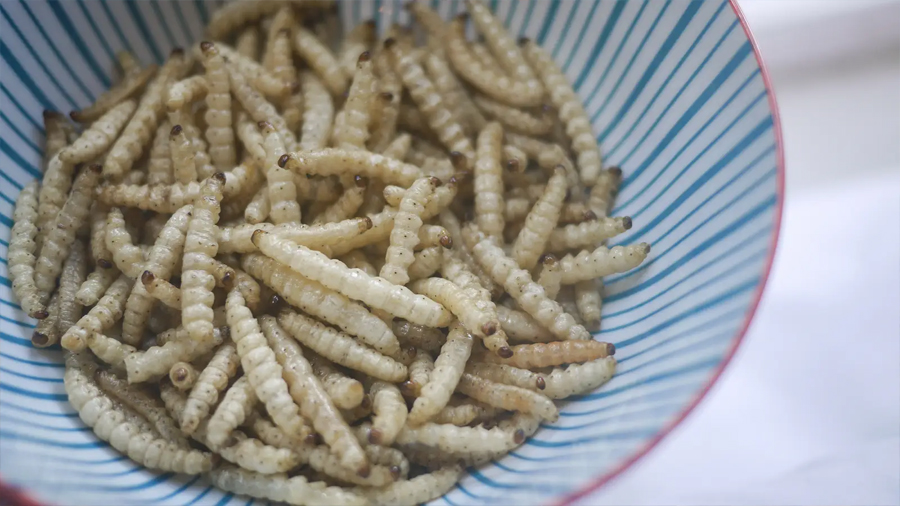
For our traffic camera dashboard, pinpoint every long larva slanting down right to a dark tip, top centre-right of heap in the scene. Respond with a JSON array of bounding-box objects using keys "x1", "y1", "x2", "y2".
[{"x1": 384, "y1": 39, "x2": 475, "y2": 160}]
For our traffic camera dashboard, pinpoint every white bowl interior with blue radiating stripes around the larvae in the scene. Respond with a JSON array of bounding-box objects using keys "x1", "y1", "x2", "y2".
[{"x1": 0, "y1": 0, "x2": 784, "y2": 505}]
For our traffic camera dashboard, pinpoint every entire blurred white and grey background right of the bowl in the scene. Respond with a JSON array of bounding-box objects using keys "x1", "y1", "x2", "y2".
[{"x1": 579, "y1": 0, "x2": 900, "y2": 505}]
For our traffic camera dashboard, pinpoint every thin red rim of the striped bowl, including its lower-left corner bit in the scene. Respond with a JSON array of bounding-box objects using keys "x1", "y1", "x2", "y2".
[{"x1": 0, "y1": 0, "x2": 785, "y2": 506}]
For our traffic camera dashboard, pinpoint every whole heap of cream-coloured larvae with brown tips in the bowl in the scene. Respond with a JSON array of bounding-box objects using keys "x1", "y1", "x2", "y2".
[{"x1": 9, "y1": 0, "x2": 650, "y2": 504}]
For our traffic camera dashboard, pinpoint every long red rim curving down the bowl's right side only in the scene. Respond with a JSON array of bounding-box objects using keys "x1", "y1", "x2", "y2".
[{"x1": 554, "y1": 0, "x2": 785, "y2": 506}]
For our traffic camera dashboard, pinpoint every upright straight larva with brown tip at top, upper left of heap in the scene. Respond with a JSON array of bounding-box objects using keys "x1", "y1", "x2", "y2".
[{"x1": 200, "y1": 41, "x2": 237, "y2": 171}]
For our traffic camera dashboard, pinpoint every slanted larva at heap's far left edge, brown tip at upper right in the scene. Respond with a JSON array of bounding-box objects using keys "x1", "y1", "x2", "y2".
[{"x1": 33, "y1": 165, "x2": 101, "y2": 296}]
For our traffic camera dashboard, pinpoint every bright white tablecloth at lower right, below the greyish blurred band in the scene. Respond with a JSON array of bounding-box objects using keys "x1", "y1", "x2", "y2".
[{"x1": 579, "y1": 170, "x2": 900, "y2": 505}]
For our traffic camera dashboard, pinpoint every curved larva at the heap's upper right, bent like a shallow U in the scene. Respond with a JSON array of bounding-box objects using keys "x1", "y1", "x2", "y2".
[{"x1": 444, "y1": 15, "x2": 544, "y2": 107}]
